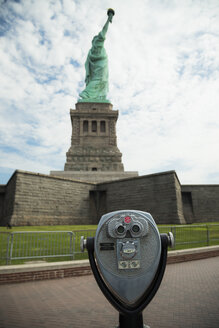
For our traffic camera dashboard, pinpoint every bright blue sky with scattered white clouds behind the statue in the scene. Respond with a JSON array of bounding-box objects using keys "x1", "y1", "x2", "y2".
[{"x1": 0, "y1": 0, "x2": 219, "y2": 184}]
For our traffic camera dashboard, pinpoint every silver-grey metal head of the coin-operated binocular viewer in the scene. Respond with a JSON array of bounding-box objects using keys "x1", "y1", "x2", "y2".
[{"x1": 81, "y1": 210, "x2": 173, "y2": 308}]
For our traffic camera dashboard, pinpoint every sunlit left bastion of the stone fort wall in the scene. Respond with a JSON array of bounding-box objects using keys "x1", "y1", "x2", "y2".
[{"x1": 1, "y1": 171, "x2": 93, "y2": 226}]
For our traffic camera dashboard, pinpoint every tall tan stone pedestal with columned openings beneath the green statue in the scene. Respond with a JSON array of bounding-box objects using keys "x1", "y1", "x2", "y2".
[{"x1": 50, "y1": 102, "x2": 138, "y2": 182}]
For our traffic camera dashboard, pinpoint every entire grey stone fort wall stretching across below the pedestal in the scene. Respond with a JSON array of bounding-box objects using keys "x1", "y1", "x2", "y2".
[{"x1": 0, "y1": 171, "x2": 219, "y2": 225}]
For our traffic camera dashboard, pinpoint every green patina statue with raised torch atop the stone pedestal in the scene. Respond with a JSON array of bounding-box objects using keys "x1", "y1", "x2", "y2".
[{"x1": 78, "y1": 9, "x2": 115, "y2": 103}]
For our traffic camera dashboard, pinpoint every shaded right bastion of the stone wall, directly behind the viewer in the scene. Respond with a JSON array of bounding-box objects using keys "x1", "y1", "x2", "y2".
[{"x1": 96, "y1": 171, "x2": 185, "y2": 224}]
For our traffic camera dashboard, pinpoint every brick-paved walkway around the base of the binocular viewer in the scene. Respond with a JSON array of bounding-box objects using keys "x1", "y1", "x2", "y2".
[{"x1": 0, "y1": 257, "x2": 219, "y2": 328}]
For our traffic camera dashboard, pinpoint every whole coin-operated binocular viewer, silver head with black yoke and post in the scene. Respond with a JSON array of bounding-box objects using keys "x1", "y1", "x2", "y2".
[{"x1": 81, "y1": 210, "x2": 174, "y2": 328}]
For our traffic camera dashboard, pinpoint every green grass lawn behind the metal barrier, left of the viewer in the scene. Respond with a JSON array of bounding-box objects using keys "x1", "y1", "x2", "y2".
[{"x1": 0, "y1": 225, "x2": 97, "y2": 265}]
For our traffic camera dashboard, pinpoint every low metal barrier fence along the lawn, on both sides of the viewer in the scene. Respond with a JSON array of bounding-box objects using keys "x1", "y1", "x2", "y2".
[{"x1": 0, "y1": 224, "x2": 219, "y2": 265}]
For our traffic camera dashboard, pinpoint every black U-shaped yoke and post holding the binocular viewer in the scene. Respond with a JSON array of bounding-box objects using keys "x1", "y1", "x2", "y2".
[{"x1": 86, "y1": 234, "x2": 171, "y2": 328}]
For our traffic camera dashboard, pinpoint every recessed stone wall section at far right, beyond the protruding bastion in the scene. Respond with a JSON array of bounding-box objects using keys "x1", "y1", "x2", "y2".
[{"x1": 182, "y1": 185, "x2": 219, "y2": 223}]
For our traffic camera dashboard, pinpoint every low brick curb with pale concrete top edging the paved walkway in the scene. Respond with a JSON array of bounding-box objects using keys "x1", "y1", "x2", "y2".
[{"x1": 0, "y1": 245, "x2": 219, "y2": 284}]
